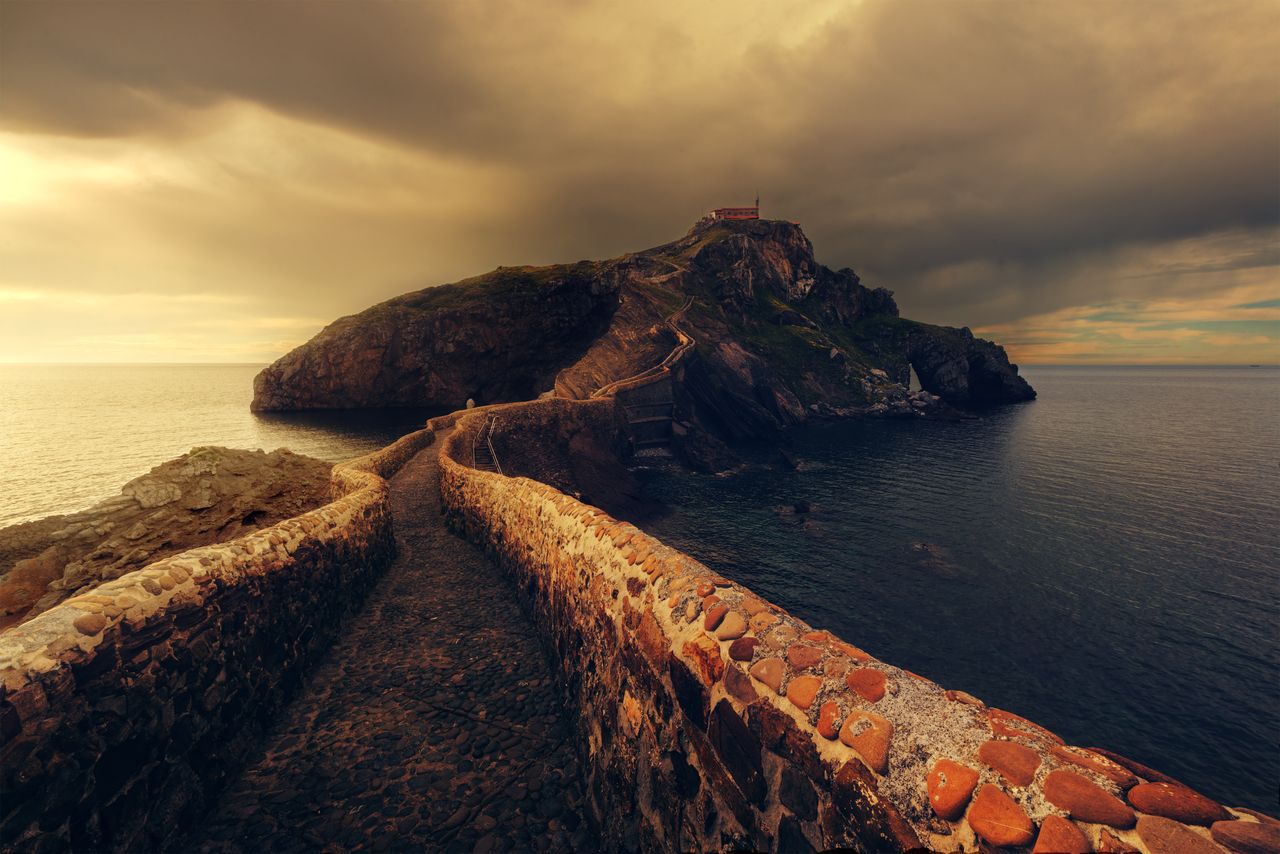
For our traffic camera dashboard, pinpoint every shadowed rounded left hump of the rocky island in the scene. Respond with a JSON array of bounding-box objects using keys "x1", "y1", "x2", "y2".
[{"x1": 252, "y1": 262, "x2": 618, "y2": 411}]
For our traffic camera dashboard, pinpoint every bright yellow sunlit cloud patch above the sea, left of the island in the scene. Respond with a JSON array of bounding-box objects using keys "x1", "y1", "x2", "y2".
[{"x1": 0, "y1": 104, "x2": 521, "y2": 361}]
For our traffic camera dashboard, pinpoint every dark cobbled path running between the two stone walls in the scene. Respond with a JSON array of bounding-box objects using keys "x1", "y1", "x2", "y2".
[{"x1": 180, "y1": 435, "x2": 596, "y2": 851}]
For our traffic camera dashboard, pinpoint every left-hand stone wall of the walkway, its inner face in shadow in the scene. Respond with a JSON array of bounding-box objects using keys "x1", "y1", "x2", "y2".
[{"x1": 0, "y1": 430, "x2": 434, "y2": 850}]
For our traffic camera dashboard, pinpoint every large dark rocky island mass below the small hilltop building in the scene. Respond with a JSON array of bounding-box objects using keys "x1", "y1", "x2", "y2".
[{"x1": 253, "y1": 220, "x2": 1034, "y2": 440}]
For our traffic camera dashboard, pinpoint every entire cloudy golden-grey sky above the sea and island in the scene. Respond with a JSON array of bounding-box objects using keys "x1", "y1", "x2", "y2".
[{"x1": 0, "y1": 0, "x2": 1280, "y2": 364}]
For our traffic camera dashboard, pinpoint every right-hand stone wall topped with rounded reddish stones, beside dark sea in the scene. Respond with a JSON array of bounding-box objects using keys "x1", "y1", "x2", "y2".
[{"x1": 440, "y1": 403, "x2": 1280, "y2": 853}]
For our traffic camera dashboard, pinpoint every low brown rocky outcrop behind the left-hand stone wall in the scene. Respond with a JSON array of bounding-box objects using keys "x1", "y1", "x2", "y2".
[{"x1": 0, "y1": 447, "x2": 332, "y2": 627}]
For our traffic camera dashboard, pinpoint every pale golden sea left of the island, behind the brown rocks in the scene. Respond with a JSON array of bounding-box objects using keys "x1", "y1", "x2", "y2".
[{"x1": 0, "y1": 365, "x2": 433, "y2": 526}]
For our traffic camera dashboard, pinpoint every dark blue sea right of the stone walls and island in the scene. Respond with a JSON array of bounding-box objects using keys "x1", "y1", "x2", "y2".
[{"x1": 641, "y1": 367, "x2": 1280, "y2": 814}]
